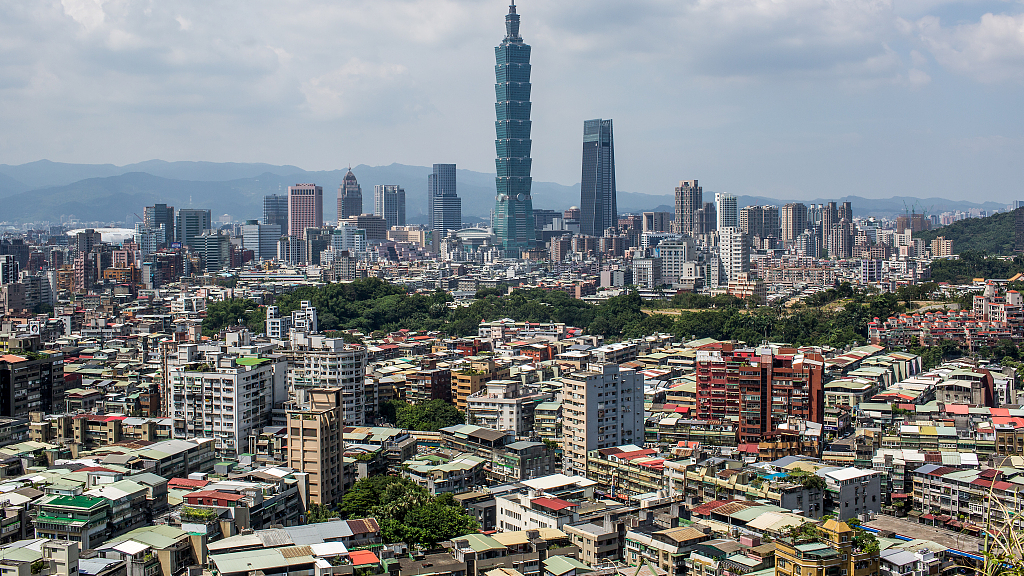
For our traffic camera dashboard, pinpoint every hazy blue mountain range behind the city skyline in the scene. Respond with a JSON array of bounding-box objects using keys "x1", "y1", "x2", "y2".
[{"x1": 0, "y1": 160, "x2": 1006, "y2": 223}]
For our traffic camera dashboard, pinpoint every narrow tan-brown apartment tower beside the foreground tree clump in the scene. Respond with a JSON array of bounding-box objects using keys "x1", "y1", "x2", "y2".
[{"x1": 288, "y1": 387, "x2": 345, "y2": 505}]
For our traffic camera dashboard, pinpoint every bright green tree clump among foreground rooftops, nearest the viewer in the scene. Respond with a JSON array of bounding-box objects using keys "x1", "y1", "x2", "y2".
[{"x1": 341, "y1": 476, "x2": 479, "y2": 546}]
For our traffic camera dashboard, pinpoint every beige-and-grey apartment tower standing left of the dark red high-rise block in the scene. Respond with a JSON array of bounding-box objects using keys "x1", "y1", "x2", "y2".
[{"x1": 562, "y1": 363, "x2": 644, "y2": 476}]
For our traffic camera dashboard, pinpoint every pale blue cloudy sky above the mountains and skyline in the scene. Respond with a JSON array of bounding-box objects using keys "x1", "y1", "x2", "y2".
[{"x1": 0, "y1": 0, "x2": 1024, "y2": 202}]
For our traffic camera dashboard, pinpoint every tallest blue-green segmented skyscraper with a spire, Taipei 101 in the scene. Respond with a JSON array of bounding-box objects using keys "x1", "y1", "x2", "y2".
[{"x1": 494, "y1": 4, "x2": 535, "y2": 256}]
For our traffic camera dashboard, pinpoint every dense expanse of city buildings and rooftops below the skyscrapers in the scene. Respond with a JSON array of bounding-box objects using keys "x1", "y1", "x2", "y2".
[{"x1": 0, "y1": 203, "x2": 1024, "y2": 576}]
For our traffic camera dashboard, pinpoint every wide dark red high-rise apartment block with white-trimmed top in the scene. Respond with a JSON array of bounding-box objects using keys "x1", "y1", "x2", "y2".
[{"x1": 696, "y1": 343, "x2": 824, "y2": 443}]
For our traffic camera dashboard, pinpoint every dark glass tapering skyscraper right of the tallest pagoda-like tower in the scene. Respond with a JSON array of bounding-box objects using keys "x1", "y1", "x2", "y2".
[{"x1": 580, "y1": 119, "x2": 618, "y2": 236}]
